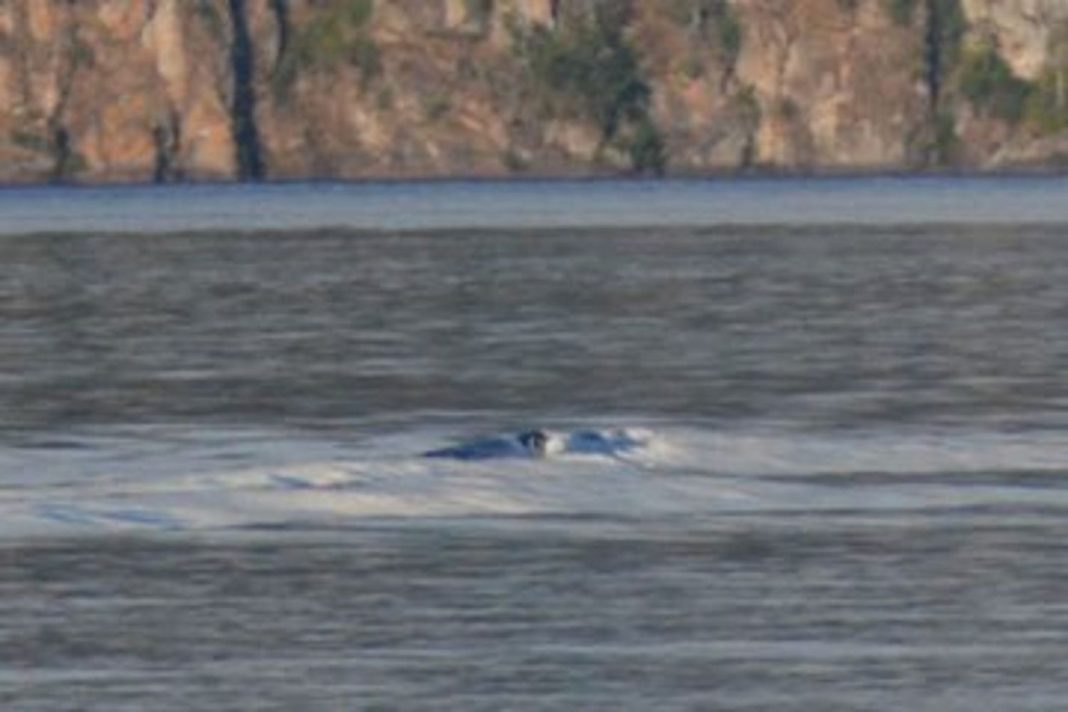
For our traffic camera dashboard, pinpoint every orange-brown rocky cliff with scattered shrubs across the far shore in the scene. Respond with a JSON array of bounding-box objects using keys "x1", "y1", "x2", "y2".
[{"x1": 0, "y1": 0, "x2": 1068, "y2": 181}]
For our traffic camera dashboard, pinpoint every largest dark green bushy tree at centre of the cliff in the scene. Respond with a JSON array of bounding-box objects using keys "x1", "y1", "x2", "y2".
[{"x1": 515, "y1": 12, "x2": 665, "y2": 173}]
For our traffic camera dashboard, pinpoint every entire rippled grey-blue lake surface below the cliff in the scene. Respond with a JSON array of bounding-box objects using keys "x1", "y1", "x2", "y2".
[{"x1": 0, "y1": 178, "x2": 1068, "y2": 712}]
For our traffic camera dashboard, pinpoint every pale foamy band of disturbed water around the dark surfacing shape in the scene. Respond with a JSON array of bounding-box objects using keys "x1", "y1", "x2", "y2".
[{"x1": 6, "y1": 428, "x2": 1068, "y2": 538}]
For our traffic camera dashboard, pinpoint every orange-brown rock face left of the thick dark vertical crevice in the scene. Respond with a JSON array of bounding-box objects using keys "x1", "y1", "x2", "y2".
[{"x1": 0, "y1": 0, "x2": 234, "y2": 181}]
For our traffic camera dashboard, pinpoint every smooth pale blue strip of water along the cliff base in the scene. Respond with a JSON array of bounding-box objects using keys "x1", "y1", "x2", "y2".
[{"x1": 6, "y1": 176, "x2": 1068, "y2": 235}]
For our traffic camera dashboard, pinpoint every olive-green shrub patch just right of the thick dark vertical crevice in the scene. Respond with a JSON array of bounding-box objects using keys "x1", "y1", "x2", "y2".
[{"x1": 271, "y1": 0, "x2": 382, "y2": 98}]
